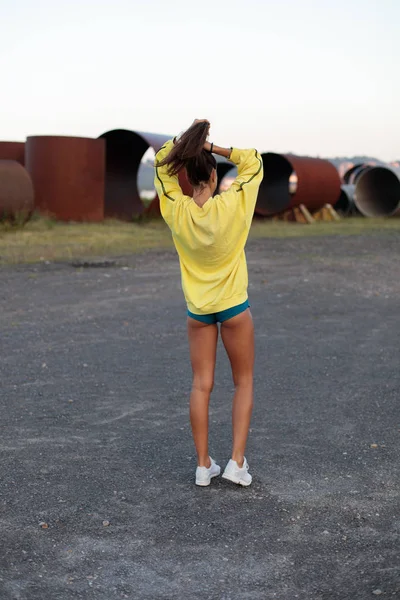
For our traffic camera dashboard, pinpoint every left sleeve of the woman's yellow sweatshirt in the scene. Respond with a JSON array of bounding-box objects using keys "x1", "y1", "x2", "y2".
[{"x1": 154, "y1": 140, "x2": 183, "y2": 225}]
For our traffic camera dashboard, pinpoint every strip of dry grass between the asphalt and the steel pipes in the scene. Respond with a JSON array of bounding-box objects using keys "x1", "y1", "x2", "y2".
[{"x1": 0, "y1": 213, "x2": 400, "y2": 265}]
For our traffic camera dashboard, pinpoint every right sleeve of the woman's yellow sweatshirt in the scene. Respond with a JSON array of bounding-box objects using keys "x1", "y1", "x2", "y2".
[{"x1": 220, "y1": 148, "x2": 264, "y2": 223}]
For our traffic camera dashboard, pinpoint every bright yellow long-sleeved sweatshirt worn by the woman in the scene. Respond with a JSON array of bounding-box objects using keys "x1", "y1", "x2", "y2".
[{"x1": 154, "y1": 140, "x2": 263, "y2": 315}]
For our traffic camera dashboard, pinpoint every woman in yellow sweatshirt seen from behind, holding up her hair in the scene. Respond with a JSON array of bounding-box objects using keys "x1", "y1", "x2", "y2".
[{"x1": 154, "y1": 120, "x2": 263, "y2": 486}]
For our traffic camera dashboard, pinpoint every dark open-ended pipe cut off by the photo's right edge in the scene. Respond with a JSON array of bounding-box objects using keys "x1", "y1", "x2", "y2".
[{"x1": 344, "y1": 165, "x2": 400, "y2": 217}]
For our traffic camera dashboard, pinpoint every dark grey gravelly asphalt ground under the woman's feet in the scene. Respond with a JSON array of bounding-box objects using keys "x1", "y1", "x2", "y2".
[{"x1": 0, "y1": 234, "x2": 400, "y2": 600}]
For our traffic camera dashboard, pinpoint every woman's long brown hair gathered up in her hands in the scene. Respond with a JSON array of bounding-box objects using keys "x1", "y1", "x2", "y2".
[{"x1": 157, "y1": 122, "x2": 217, "y2": 187}]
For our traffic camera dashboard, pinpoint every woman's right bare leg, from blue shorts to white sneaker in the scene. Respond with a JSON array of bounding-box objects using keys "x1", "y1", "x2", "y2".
[{"x1": 221, "y1": 309, "x2": 254, "y2": 467}]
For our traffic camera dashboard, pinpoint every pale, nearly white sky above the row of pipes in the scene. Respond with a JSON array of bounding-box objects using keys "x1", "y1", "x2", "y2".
[{"x1": 0, "y1": 0, "x2": 400, "y2": 160}]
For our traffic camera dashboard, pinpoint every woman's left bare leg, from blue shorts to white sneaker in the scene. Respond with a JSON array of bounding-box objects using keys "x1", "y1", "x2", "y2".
[{"x1": 188, "y1": 317, "x2": 218, "y2": 468}]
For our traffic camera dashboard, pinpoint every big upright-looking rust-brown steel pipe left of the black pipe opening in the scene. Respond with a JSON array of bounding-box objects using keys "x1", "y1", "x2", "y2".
[{"x1": 25, "y1": 136, "x2": 105, "y2": 221}]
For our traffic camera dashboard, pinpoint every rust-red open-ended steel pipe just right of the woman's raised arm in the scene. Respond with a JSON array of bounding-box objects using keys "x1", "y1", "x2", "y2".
[{"x1": 256, "y1": 152, "x2": 340, "y2": 216}]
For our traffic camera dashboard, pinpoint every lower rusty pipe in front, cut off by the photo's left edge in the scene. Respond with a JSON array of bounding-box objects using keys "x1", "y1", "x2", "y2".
[{"x1": 0, "y1": 160, "x2": 33, "y2": 219}]
